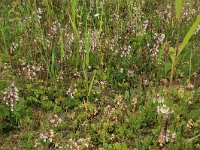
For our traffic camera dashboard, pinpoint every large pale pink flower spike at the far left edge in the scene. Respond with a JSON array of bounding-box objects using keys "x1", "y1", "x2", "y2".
[{"x1": 3, "y1": 82, "x2": 19, "y2": 111}]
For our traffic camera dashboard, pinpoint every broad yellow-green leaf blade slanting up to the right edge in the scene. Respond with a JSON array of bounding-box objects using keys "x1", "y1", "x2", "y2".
[{"x1": 177, "y1": 15, "x2": 200, "y2": 56}]
